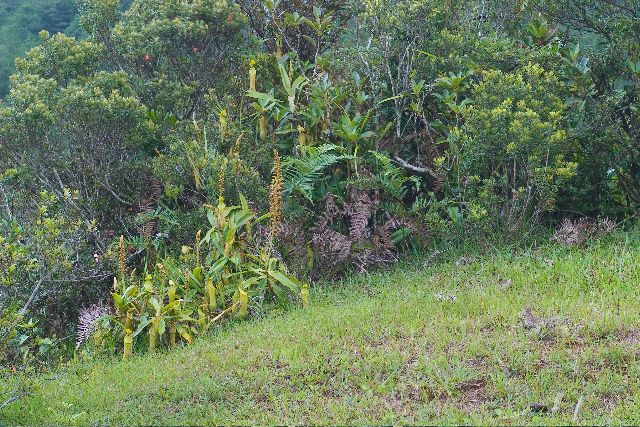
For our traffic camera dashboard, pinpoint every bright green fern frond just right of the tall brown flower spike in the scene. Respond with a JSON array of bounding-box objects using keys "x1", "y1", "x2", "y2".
[{"x1": 283, "y1": 144, "x2": 353, "y2": 202}]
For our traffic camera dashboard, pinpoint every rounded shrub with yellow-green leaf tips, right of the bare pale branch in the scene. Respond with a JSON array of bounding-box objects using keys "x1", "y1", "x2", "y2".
[{"x1": 443, "y1": 64, "x2": 578, "y2": 231}]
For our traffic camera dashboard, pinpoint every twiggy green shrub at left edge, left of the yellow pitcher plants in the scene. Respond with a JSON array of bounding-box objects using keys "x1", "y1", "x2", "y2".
[{"x1": 0, "y1": 191, "x2": 101, "y2": 367}]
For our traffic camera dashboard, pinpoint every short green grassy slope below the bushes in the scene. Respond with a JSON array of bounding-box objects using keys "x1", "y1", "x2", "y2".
[{"x1": 0, "y1": 234, "x2": 640, "y2": 425}]
